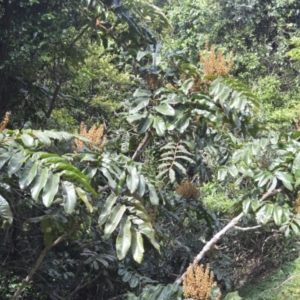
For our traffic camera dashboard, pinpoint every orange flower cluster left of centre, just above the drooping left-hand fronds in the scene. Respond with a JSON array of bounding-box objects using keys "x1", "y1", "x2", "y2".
[{"x1": 75, "y1": 122, "x2": 106, "y2": 150}]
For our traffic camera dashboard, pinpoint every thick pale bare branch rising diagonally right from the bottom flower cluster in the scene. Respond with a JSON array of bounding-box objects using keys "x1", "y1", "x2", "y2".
[{"x1": 174, "y1": 186, "x2": 285, "y2": 284}]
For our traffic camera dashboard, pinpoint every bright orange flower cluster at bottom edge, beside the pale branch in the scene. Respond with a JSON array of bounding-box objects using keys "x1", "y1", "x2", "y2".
[{"x1": 183, "y1": 264, "x2": 222, "y2": 300}]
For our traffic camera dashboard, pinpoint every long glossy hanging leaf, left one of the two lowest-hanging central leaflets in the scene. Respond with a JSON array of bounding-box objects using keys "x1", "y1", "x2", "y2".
[{"x1": 116, "y1": 217, "x2": 131, "y2": 260}]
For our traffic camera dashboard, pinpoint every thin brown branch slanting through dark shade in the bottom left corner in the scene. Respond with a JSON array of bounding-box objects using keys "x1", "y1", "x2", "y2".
[{"x1": 11, "y1": 228, "x2": 75, "y2": 300}]
